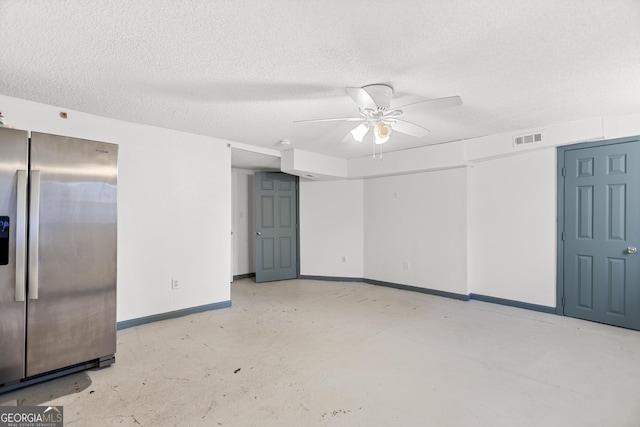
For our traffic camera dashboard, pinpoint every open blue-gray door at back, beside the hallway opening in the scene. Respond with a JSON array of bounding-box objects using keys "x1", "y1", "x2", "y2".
[{"x1": 253, "y1": 172, "x2": 298, "y2": 282}]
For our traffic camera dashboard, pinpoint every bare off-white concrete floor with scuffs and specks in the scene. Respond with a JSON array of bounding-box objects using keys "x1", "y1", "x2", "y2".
[{"x1": 0, "y1": 279, "x2": 640, "y2": 427}]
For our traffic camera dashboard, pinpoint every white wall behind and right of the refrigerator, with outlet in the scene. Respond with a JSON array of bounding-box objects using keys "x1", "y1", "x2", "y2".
[{"x1": 0, "y1": 95, "x2": 231, "y2": 321}]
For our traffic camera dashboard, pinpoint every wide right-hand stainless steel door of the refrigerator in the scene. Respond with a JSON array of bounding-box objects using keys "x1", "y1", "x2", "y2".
[{"x1": 26, "y1": 132, "x2": 118, "y2": 376}]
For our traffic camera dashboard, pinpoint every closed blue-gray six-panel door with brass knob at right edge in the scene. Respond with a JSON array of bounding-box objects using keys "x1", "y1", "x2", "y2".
[{"x1": 561, "y1": 139, "x2": 640, "y2": 329}]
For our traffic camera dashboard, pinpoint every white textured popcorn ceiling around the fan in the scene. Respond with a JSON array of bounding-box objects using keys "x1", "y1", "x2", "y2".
[{"x1": 0, "y1": 0, "x2": 640, "y2": 158}]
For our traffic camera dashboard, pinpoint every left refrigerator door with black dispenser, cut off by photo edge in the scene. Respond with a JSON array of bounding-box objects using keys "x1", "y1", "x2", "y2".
[{"x1": 0, "y1": 127, "x2": 29, "y2": 384}]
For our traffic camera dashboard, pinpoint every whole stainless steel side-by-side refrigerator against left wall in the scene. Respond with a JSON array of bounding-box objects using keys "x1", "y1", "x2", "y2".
[{"x1": 0, "y1": 127, "x2": 118, "y2": 393}]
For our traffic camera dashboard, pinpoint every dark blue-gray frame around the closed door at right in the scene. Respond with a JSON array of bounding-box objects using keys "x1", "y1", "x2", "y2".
[{"x1": 556, "y1": 135, "x2": 640, "y2": 316}]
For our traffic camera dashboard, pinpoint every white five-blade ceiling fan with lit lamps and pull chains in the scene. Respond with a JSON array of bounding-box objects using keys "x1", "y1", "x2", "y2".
[{"x1": 295, "y1": 84, "x2": 462, "y2": 152}]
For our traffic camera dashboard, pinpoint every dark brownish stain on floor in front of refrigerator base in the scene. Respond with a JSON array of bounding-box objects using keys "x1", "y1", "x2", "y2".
[{"x1": 0, "y1": 372, "x2": 91, "y2": 406}]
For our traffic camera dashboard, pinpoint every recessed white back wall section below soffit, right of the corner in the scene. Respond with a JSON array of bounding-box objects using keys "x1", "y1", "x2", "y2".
[{"x1": 364, "y1": 168, "x2": 468, "y2": 295}]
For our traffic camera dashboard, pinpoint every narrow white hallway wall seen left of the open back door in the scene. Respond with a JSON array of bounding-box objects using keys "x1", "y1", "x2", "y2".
[{"x1": 231, "y1": 168, "x2": 255, "y2": 276}]
